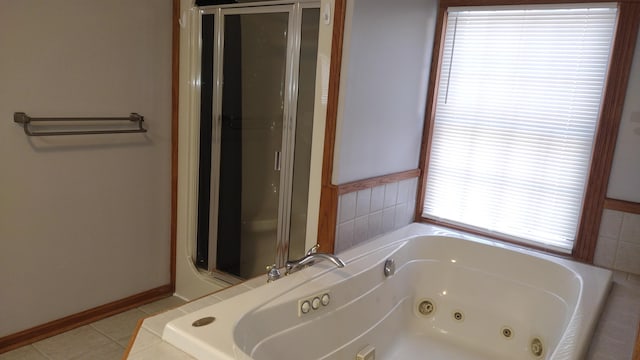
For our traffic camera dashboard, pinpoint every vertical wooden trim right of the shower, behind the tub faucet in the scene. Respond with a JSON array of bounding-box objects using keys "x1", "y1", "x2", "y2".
[{"x1": 318, "y1": 0, "x2": 347, "y2": 253}]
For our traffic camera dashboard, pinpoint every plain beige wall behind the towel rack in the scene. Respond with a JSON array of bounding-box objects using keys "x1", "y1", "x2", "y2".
[{"x1": 0, "y1": 0, "x2": 171, "y2": 336}]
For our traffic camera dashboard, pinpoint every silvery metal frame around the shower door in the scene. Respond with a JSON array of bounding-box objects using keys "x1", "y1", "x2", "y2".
[{"x1": 196, "y1": 0, "x2": 320, "y2": 276}]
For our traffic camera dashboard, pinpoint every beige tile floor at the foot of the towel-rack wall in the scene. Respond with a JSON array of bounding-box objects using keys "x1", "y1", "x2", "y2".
[{"x1": 0, "y1": 296, "x2": 185, "y2": 360}]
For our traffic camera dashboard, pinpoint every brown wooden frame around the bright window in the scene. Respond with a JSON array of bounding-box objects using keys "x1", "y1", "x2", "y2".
[{"x1": 415, "y1": 0, "x2": 640, "y2": 263}]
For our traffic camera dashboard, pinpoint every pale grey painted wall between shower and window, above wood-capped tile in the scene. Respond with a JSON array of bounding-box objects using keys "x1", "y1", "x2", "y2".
[{"x1": 333, "y1": 0, "x2": 437, "y2": 184}]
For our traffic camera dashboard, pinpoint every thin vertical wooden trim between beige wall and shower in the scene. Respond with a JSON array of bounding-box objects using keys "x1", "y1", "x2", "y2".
[{"x1": 169, "y1": 0, "x2": 180, "y2": 292}]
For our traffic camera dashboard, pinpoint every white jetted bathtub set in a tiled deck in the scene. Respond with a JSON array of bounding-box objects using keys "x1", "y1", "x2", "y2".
[{"x1": 163, "y1": 224, "x2": 612, "y2": 360}]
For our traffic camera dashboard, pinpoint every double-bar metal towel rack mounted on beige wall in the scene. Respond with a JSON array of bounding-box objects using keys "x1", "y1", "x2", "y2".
[{"x1": 13, "y1": 112, "x2": 147, "y2": 136}]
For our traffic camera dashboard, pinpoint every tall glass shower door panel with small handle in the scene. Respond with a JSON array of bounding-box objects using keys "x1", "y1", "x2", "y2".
[{"x1": 215, "y1": 10, "x2": 290, "y2": 278}]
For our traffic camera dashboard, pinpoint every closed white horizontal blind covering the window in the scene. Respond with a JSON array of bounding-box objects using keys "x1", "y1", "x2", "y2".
[{"x1": 423, "y1": 4, "x2": 617, "y2": 252}]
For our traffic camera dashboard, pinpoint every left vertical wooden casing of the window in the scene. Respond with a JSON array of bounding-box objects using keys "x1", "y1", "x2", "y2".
[{"x1": 414, "y1": 6, "x2": 447, "y2": 219}]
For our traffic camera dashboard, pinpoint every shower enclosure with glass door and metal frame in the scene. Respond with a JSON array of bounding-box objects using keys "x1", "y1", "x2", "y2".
[{"x1": 195, "y1": 2, "x2": 320, "y2": 282}]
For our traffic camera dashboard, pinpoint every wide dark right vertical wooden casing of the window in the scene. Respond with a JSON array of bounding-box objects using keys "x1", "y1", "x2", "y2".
[{"x1": 573, "y1": 3, "x2": 640, "y2": 263}]
